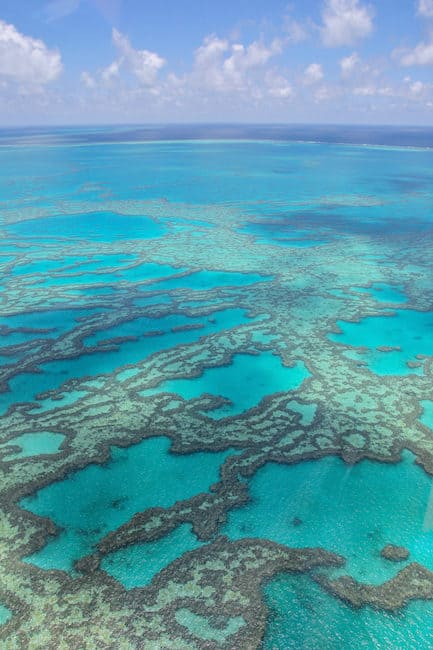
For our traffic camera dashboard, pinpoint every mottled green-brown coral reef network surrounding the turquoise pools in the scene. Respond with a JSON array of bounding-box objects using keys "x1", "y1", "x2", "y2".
[{"x1": 0, "y1": 184, "x2": 433, "y2": 650}]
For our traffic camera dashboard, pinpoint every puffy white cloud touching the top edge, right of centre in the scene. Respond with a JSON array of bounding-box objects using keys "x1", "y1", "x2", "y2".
[{"x1": 321, "y1": 0, "x2": 373, "y2": 47}]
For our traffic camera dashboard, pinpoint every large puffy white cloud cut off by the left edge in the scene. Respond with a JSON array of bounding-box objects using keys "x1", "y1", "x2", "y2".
[{"x1": 0, "y1": 20, "x2": 62, "y2": 86}]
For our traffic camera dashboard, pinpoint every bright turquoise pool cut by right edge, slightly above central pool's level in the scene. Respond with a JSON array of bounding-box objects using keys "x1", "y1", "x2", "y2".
[{"x1": 329, "y1": 309, "x2": 433, "y2": 375}]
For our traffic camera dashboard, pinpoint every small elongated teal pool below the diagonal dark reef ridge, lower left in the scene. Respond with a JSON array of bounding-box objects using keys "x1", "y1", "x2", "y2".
[{"x1": 101, "y1": 524, "x2": 203, "y2": 589}]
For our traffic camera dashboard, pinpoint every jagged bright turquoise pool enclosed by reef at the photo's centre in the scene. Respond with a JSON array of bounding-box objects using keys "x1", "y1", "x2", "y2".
[{"x1": 140, "y1": 352, "x2": 310, "y2": 419}]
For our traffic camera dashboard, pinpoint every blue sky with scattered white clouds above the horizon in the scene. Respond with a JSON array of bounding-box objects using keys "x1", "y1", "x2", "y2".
[{"x1": 0, "y1": 0, "x2": 433, "y2": 126}]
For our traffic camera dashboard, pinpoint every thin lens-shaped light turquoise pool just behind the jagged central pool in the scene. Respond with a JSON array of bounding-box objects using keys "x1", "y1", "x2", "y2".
[{"x1": 146, "y1": 270, "x2": 272, "y2": 291}]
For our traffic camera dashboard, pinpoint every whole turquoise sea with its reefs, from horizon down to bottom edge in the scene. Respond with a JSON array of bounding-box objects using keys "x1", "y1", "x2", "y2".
[{"x1": 0, "y1": 125, "x2": 433, "y2": 650}]
